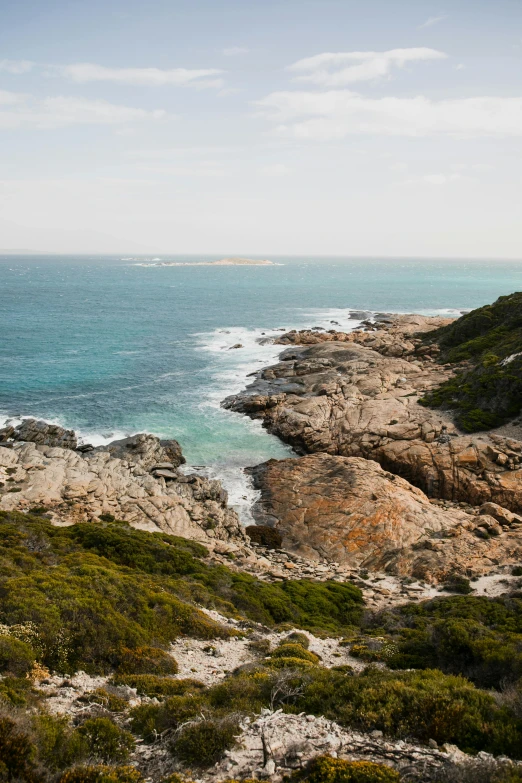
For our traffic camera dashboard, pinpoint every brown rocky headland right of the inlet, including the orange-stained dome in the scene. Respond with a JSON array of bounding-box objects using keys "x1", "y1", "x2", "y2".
[{"x1": 224, "y1": 306, "x2": 522, "y2": 582}]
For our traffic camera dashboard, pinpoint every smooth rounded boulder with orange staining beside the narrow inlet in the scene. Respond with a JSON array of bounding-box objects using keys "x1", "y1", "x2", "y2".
[{"x1": 248, "y1": 454, "x2": 472, "y2": 568}]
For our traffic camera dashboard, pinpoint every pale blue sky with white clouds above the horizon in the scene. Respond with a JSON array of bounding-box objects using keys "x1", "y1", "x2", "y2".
[{"x1": 0, "y1": 0, "x2": 522, "y2": 259}]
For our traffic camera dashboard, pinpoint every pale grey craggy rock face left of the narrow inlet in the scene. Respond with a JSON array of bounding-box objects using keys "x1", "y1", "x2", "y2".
[{"x1": 0, "y1": 435, "x2": 246, "y2": 543}]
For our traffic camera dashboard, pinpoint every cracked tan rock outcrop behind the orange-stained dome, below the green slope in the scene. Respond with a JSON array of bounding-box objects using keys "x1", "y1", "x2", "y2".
[{"x1": 223, "y1": 316, "x2": 522, "y2": 512}]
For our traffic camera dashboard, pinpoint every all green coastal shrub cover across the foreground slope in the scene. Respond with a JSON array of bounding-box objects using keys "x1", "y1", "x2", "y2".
[{"x1": 0, "y1": 512, "x2": 522, "y2": 783}]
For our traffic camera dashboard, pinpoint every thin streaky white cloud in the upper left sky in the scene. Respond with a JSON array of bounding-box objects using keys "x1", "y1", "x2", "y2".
[{"x1": 57, "y1": 63, "x2": 223, "y2": 88}]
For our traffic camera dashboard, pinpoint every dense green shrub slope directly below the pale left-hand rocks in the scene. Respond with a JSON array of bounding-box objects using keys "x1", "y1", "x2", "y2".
[{"x1": 0, "y1": 512, "x2": 362, "y2": 673}]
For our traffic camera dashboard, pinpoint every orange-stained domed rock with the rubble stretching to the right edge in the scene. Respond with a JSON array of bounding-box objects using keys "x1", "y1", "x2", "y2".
[{"x1": 246, "y1": 454, "x2": 522, "y2": 582}]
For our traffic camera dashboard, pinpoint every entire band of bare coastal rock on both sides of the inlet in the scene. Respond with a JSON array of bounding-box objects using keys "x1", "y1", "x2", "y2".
[{"x1": 4, "y1": 316, "x2": 522, "y2": 601}]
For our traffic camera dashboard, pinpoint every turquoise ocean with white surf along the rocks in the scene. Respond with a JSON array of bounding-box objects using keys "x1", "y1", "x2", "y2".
[{"x1": 0, "y1": 254, "x2": 522, "y2": 521}]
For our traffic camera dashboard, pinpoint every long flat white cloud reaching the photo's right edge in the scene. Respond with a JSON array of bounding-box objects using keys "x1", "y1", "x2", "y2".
[{"x1": 255, "y1": 90, "x2": 522, "y2": 140}]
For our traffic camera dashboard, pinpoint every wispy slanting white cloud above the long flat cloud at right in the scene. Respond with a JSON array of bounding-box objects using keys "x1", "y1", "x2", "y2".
[{"x1": 288, "y1": 47, "x2": 448, "y2": 87}]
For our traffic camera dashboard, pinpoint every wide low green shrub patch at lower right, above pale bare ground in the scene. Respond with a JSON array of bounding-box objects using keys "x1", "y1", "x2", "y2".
[{"x1": 295, "y1": 668, "x2": 522, "y2": 758}]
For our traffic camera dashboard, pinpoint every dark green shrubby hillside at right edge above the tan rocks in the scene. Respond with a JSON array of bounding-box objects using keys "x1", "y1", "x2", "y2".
[{"x1": 421, "y1": 292, "x2": 522, "y2": 432}]
